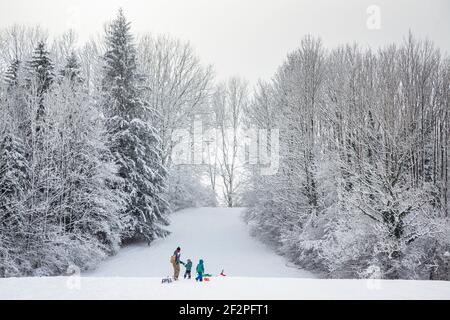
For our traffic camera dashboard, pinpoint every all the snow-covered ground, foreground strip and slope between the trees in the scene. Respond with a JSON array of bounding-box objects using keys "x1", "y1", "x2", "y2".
[{"x1": 0, "y1": 208, "x2": 450, "y2": 300}]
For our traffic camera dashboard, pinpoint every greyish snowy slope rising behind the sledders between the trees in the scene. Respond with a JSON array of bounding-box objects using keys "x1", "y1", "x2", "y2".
[{"x1": 85, "y1": 208, "x2": 313, "y2": 278}]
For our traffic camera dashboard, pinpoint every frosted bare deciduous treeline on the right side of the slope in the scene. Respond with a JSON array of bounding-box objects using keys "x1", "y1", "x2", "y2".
[{"x1": 246, "y1": 35, "x2": 450, "y2": 279}]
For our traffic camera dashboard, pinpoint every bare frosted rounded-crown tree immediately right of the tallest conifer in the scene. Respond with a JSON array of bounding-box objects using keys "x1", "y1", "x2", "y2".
[{"x1": 138, "y1": 35, "x2": 213, "y2": 166}]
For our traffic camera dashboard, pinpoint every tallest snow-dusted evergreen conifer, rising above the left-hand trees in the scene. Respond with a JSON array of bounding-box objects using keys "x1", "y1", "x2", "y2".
[{"x1": 103, "y1": 10, "x2": 168, "y2": 243}]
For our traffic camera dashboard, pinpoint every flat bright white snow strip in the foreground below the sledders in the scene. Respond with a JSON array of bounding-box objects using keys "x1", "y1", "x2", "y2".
[{"x1": 0, "y1": 277, "x2": 450, "y2": 300}]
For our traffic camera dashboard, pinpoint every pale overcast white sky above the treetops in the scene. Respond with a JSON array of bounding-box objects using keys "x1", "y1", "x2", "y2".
[{"x1": 0, "y1": 0, "x2": 450, "y2": 83}]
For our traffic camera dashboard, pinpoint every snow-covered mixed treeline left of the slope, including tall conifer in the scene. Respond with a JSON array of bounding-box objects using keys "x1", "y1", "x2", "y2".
[{"x1": 0, "y1": 10, "x2": 216, "y2": 277}]
